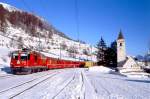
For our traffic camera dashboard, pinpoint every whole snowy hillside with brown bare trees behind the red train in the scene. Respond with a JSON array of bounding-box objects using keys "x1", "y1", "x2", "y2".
[{"x1": 0, "y1": 3, "x2": 97, "y2": 61}]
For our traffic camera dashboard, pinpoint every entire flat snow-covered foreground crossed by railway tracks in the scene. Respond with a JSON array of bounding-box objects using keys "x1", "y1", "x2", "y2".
[{"x1": 0, "y1": 68, "x2": 150, "y2": 99}]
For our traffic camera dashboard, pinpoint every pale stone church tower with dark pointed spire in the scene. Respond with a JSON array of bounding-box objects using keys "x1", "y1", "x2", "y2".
[{"x1": 117, "y1": 30, "x2": 126, "y2": 66}]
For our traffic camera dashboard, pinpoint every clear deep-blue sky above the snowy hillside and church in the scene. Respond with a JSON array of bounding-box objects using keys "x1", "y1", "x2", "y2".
[{"x1": 0, "y1": 0, "x2": 150, "y2": 55}]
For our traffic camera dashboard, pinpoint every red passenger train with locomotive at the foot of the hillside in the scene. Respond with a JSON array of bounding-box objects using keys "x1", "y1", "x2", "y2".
[{"x1": 10, "y1": 49, "x2": 85, "y2": 74}]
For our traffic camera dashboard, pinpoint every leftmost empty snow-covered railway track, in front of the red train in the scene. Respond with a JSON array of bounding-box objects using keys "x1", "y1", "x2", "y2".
[{"x1": 0, "y1": 71, "x2": 60, "y2": 99}]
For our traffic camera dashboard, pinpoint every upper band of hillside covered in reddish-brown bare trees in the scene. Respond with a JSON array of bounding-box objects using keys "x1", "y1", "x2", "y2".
[{"x1": 0, "y1": 3, "x2": 68, "y2": 38}]
